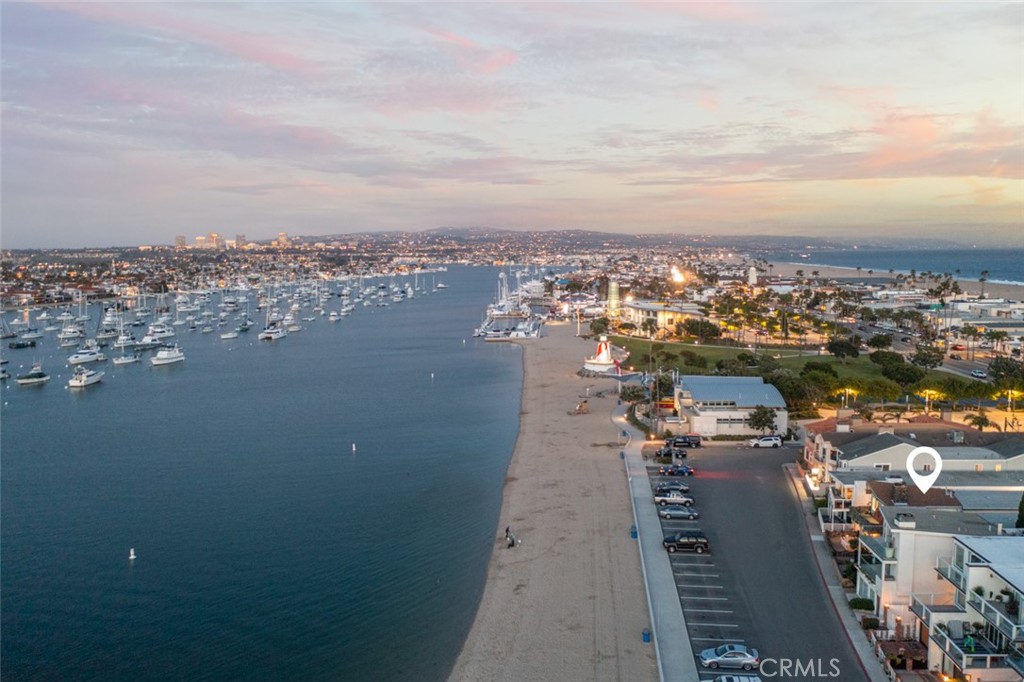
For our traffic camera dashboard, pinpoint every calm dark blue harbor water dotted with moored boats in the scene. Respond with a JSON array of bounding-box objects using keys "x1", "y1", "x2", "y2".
[{"x1": 0, "y1": 266, "x2": 522, "y2": 680}]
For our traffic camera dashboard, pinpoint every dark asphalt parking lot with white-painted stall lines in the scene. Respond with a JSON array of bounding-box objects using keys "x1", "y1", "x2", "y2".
[{"x1": 651, "y1": 446, "x2": 866, "y2": 682}]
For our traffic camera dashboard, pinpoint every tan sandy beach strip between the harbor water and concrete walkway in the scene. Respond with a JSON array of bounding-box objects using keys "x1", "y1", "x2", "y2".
[{"x1": 450, "y1": 324, "x2": 657, "y2": 682}]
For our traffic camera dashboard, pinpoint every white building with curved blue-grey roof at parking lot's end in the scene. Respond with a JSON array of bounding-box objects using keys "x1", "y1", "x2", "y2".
[{"x1": 675, "y1": 375, "x2": 790, "y2": 437}]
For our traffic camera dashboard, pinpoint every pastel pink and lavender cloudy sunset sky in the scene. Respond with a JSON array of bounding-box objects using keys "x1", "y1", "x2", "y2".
[{"x1": 0, "y1": 2, "x2": 1024, "y2": 248}]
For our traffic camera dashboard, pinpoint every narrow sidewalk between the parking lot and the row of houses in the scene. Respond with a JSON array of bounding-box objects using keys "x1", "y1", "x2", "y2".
[{"x1": 782, "y1": 464, "x2": 889, "y2": 682}]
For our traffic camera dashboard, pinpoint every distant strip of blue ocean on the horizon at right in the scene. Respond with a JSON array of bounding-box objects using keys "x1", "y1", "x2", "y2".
[{"x1": 764, "y1": 246, "x2": 1024, "y2": 284}]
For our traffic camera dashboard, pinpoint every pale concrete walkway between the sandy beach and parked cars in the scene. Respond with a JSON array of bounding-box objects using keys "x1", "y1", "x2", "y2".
[{"x1": 611, "y1": 403, "x2": 699, "y2": 682}]
